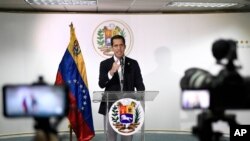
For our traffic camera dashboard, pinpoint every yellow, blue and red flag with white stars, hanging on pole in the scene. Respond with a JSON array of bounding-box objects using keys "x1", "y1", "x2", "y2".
[{"x1": 55, "y1": 24, "x2": 95, "y2": 141}]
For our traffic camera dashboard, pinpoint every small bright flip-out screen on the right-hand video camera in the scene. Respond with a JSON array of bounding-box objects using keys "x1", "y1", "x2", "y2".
[{"x1": 181, "y1": 90, "x2": 210, "y2": 109}]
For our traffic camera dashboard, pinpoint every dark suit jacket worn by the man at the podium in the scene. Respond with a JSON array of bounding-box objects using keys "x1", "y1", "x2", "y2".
[{"x1": 99, "y1": 57, "x2": 145, "y2": 115}]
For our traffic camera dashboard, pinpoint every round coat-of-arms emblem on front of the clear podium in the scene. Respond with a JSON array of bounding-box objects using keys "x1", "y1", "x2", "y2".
[{"x1": 109, "y1": 98, "x2": 144, "y2": 136}]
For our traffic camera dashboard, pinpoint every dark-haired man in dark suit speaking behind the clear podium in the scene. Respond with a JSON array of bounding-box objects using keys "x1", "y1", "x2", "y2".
[{"x1": 99, "y1": 35, "x2": 145, "y2": 141}]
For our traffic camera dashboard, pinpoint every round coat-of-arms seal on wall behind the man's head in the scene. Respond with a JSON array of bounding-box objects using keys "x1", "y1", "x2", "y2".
[{"x1": 92, "y1": 20, "x2": 134, "y2": 58}]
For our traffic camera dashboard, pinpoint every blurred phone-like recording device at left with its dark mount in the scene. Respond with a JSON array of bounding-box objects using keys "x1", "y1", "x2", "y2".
[{"x1": 3, "y1": 76, "x2": 69, "y2": 141}]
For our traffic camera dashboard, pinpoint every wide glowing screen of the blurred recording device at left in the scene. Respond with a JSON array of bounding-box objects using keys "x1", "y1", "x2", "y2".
[{"x1": 3, "y1": 85, "x2": 67, "y2": 117}]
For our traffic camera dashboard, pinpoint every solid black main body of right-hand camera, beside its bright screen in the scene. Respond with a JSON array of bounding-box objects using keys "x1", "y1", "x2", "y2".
[{"x1": 210, "y1": 66, "x2": 250, "y2": 110}]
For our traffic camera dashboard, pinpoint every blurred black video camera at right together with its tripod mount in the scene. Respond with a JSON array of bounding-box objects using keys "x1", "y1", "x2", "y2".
[{"x1": 180, "y1": 39, "x2": 250, "y2": 141}]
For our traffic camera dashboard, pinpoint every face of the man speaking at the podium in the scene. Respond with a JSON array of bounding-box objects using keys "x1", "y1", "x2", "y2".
[{"x1": 112, "y1": 39, "x2": 126, "y2": 59}]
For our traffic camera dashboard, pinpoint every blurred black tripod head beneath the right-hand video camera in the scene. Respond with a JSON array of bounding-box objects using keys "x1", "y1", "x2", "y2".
[{"x1": 192, "y1": 110, "x2": 238, "y2": 141}]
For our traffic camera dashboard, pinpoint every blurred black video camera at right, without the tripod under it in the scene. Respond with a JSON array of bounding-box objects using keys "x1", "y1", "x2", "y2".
[{"x1": 180, "y1": 39, "x2": 250, "y2": 111}]
